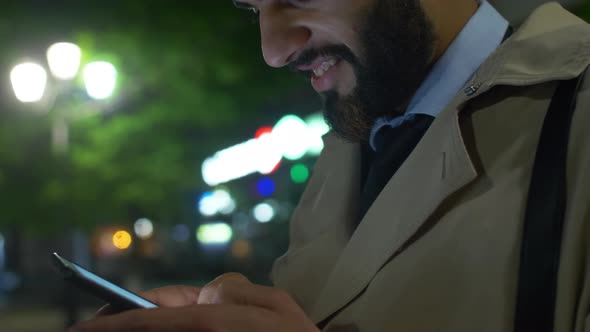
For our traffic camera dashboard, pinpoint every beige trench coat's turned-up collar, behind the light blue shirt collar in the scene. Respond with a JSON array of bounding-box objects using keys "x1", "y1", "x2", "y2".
[{"x1": 464, "y1": 2, "x2": 590, "y2": 100}]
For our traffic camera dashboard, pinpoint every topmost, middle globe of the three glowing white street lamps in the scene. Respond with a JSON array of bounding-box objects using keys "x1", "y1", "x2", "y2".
[{"x1": 47, "y1": 43, "x2": 82, "y2": 80}]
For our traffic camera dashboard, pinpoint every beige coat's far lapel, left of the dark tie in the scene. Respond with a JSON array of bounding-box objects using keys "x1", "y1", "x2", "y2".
[{"x1": 272, "y1": 133, "x2": 361, "y2": 311}]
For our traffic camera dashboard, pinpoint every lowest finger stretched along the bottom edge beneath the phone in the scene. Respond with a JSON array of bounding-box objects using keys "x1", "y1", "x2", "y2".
[{"x1": 70, "y1": 305, "x2": 278, "y2": 332}]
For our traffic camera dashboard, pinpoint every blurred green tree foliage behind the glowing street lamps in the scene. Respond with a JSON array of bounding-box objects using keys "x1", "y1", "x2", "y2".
[{"x1": 0, "y1": 1, "x2": 314, "y2": 230}]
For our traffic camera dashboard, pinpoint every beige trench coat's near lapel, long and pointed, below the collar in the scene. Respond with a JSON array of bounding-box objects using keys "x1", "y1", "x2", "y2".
[{"x1": 311, "y1": 90, "x2": 477, "y2": 322}]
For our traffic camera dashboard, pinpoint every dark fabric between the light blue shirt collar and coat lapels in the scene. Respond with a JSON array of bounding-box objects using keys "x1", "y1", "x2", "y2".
[{"x1": 358, "y1": 114, "x2": 434, "y2": 222}]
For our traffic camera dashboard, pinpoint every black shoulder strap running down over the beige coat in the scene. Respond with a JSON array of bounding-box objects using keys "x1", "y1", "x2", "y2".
[{"x1": 514, "y1": 68, "x2": 584, "y2": 332}]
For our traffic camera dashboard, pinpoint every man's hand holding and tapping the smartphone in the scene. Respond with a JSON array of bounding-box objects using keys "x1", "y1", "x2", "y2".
[{"x1": 71, "y1": 273, "x2": 319, "y2": 332}]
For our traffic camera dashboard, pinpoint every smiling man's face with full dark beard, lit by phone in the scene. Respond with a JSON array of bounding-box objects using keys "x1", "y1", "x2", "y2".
[{"x1": 234, "y1": 0, "x2": 435, "y2": 142}]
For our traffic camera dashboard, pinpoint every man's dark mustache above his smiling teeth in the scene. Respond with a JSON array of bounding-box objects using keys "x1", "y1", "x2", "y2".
[{"x1": 287, "y1": 45, "x2": 361, "y2": 78}]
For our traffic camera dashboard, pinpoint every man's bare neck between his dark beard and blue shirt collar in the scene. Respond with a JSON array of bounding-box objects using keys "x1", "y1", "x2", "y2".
[{"x1": 422, "y1": 0, "x2": 479, "y2": 63}]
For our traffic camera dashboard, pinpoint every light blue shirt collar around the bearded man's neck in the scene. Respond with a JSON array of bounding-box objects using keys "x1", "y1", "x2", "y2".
[{"x1": 370, "y1": 0, "x2": 509, "y2": 150}]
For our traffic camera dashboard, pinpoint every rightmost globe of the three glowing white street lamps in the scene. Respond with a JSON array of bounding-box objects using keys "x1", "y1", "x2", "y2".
[{"x1": 83, "y1": 61, "x2": 117, "y2": 99}]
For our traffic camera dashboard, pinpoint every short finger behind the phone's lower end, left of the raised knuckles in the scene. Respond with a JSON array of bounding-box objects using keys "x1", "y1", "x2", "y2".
[{"x1": 137, "y1": 286, "x2": 201, "y2": 307}]
